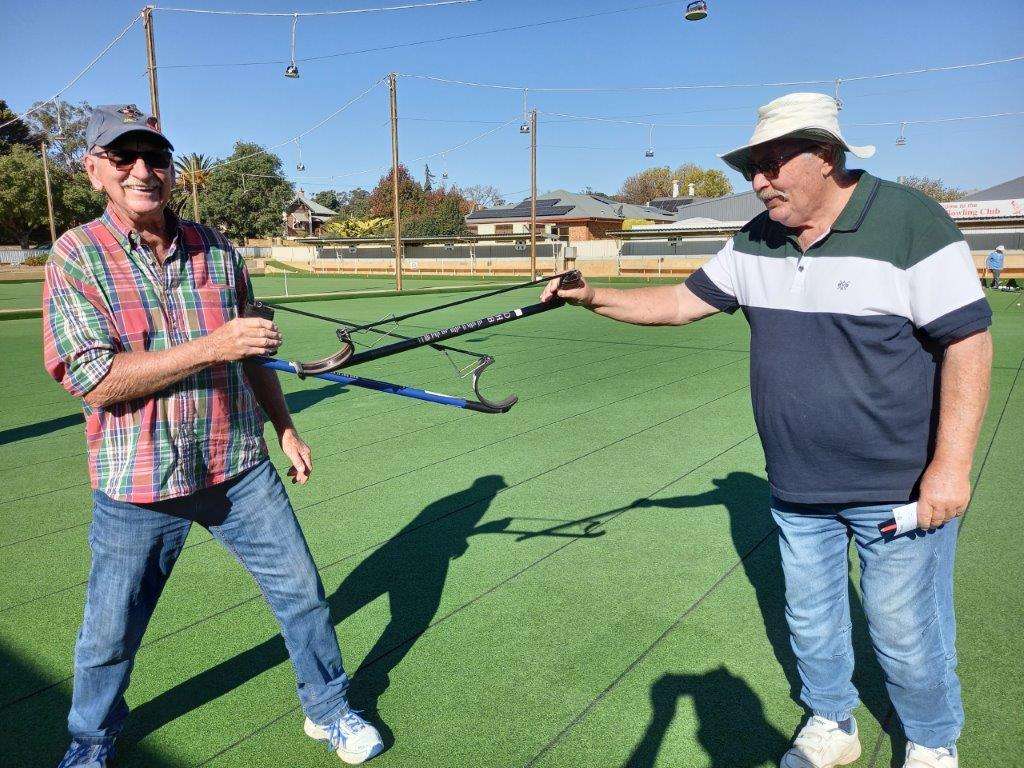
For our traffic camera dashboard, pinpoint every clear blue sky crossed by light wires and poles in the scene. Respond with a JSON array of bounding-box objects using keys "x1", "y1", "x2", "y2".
[{"x1": 0, "y1": 0, "x2": 1024, "y2": 199}]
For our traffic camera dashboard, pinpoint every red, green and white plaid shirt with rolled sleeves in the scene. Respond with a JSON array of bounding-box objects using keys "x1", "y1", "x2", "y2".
[{"x1": 43, "y1": 208, "x2": 267, "y2": 504}]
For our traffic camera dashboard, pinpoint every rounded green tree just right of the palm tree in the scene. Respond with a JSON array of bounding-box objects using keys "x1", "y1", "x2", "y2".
[{"x1": 201, "y1": 141, "x2": 295, "y2": 240}]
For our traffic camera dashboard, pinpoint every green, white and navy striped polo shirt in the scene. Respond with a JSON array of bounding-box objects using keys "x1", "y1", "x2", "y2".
[{"x1": 686, "y1": 171, "x2": 992, "y2": 504}]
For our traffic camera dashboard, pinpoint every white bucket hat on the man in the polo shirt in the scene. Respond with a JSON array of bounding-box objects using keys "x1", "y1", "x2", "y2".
[{"x1": 718, "y1": 93, "x2": 874, "y2": 173}]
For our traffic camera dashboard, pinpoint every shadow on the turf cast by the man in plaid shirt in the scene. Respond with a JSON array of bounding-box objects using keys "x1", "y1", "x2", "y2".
[{"x1": 125, "y1": 475, "x2": 509, "y2": 745}]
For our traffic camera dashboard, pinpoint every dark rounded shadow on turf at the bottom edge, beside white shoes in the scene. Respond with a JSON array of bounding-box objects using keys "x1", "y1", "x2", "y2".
[{"x1": 623, "y1": 666, "x2": 788, "y2": 768}]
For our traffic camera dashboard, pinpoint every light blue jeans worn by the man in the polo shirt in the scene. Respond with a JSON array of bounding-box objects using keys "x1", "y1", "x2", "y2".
[{"x1": 771, "y1": 499, "x2": 964, "y2": 749}]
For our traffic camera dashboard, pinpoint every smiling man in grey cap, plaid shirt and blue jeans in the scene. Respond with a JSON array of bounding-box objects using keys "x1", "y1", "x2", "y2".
[{"x1": 43, "y1": 104, "x2": 382, "y2": 768}]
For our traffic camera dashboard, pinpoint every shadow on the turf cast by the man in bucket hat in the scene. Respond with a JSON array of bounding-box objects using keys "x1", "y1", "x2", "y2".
[{"x1": 634, "y1": 472, "x2": 898, "y2": 748}]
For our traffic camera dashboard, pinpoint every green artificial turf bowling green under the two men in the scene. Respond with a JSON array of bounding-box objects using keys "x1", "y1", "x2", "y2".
[{"x1": 0, "y1": 286, "x2": 1024, "y2": 768}]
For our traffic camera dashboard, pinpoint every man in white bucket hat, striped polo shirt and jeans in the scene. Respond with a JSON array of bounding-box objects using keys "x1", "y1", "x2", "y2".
[{"x1": 543, "y1": 93, "x2": 992, "y2": 768}]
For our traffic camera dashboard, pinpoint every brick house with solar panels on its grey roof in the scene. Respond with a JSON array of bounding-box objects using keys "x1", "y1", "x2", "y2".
[{"x1": 466, "y1": 189, "x2": 676, "y2": 242}]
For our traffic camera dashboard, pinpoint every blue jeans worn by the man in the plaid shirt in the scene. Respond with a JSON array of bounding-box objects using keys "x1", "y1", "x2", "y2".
[{"x1": 68, "y1": 460, "x2": 348, "y2": 743}]
